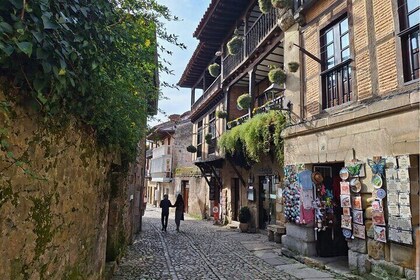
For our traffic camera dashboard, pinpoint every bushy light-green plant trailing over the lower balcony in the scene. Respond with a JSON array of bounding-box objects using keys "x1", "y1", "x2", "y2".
[{"x1": 218, "y1": 111, "x2": 285, "y2": 163}]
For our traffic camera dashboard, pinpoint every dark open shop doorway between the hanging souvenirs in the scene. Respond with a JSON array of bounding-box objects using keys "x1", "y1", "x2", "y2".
[{"x1": 312, "y1": 162, "x2": 348, "y2": 257}]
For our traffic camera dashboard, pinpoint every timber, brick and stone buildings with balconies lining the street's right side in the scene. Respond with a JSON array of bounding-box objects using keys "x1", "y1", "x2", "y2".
[{"x1": 179, "y1": 0, "x2": 420, "y2": 278}]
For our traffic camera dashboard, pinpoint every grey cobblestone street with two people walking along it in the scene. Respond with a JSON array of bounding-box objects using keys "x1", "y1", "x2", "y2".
[{"x1": 113, "y1": 206, "x2": 352, "y2": 280}]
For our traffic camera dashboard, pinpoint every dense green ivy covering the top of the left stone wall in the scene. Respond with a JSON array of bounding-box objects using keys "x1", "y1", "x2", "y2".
[{"x1": 0, "y1": 0, "x2": 184, "y2": 162}]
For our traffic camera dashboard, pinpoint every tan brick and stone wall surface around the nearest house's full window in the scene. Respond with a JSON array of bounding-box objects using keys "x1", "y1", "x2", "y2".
[{"x1": 283, "y1": 0, "x2": 420, "y2": 278}]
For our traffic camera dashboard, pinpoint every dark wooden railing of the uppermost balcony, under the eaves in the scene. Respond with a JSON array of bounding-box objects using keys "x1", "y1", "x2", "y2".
[{"x1": 222, "y1": 8, "x2": 279, "y2": 80}]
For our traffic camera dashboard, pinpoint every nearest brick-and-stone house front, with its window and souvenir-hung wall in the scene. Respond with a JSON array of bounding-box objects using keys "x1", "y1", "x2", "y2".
[{"x1": 282, "y1": 1, "x2": 420, "y2": 279}]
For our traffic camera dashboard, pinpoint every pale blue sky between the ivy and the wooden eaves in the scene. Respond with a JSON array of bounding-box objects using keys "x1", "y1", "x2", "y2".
[{"x1": 149, "y1": 0, "x2": 210, "y2": 126}]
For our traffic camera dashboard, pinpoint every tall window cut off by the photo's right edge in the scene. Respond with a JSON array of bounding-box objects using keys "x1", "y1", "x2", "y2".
[{"x1": 398, "y1": 0, "x2": 420, "y2": 82}]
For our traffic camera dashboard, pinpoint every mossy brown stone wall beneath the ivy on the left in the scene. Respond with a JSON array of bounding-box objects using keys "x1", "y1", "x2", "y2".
[{"x1": 0, "y1": 89, "x2": 140, "y2": 279}]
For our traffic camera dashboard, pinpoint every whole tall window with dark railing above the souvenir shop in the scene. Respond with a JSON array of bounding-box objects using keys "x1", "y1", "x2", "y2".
[{"x1": 321, "y1": 17, "x2": 352, "y2": 109}]
